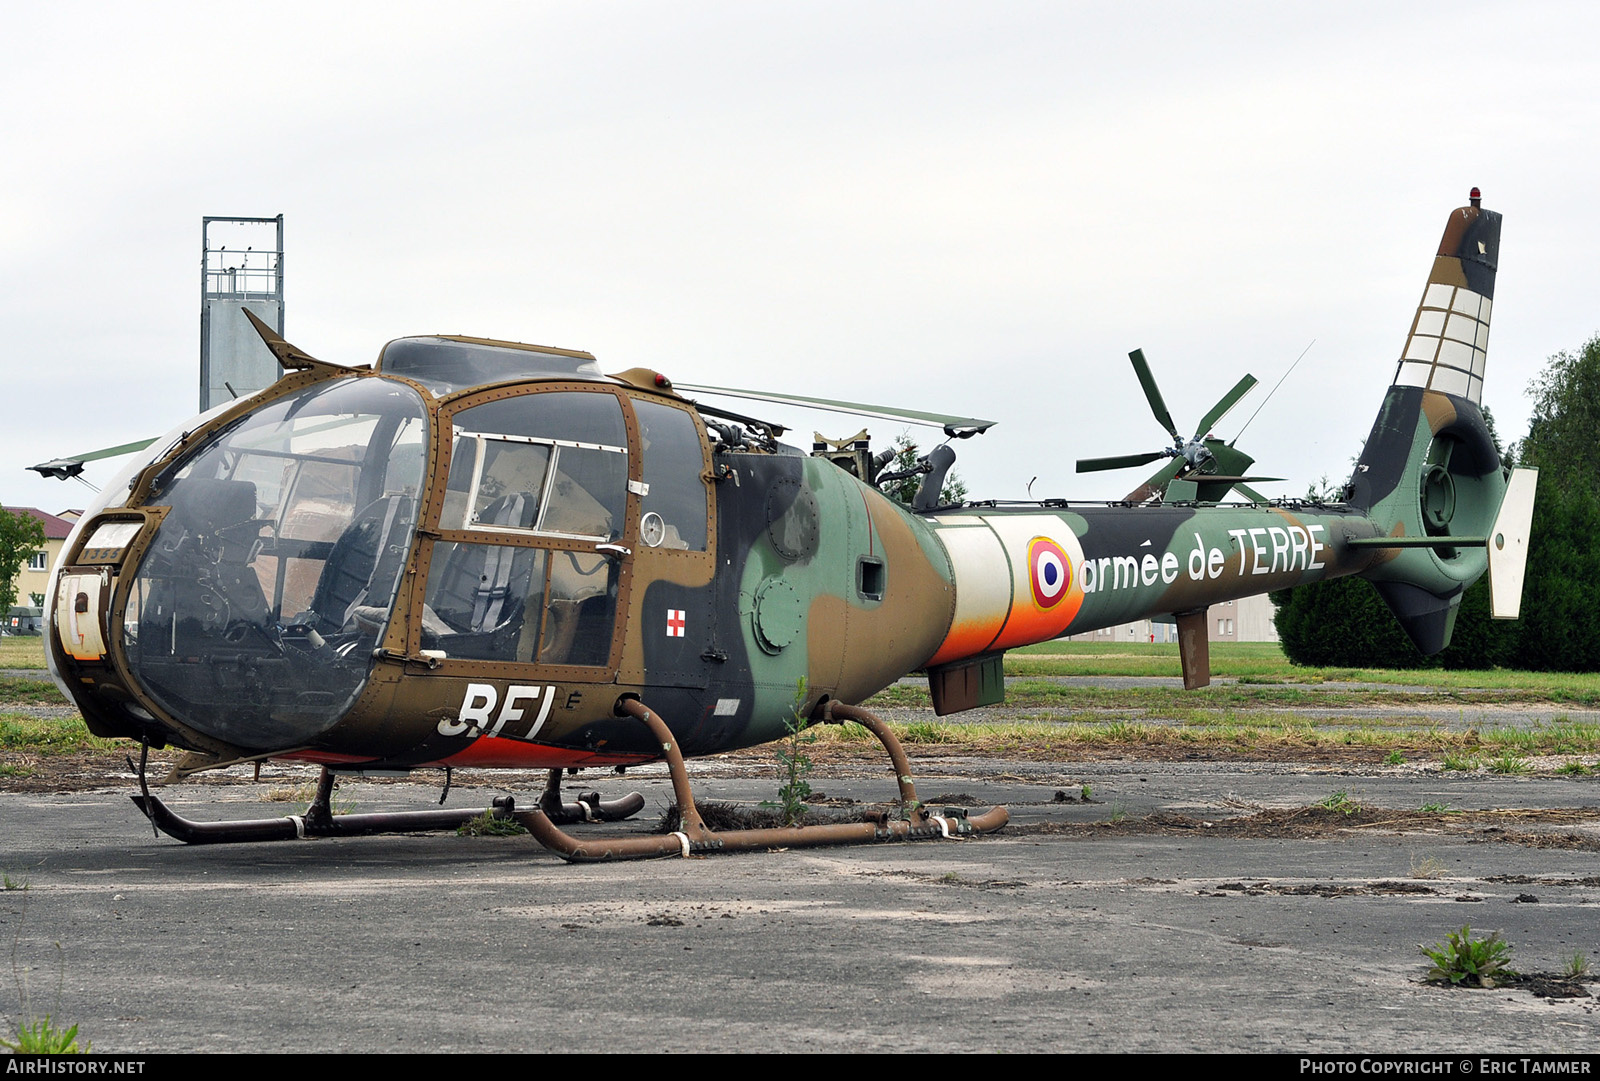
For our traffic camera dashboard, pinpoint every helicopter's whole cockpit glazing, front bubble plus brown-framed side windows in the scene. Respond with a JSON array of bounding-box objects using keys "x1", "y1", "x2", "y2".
[{"x1": 112, "y1": 362, "x2": 710, "y2": 750}]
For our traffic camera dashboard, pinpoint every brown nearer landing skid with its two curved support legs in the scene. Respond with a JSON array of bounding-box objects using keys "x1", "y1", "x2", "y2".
[{"x1": 515, "y1": 699, "x2": 1011, "y2": 864}]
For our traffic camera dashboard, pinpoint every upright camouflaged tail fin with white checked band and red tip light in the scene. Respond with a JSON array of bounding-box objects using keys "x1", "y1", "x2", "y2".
[{"x1": 1349, "y1": 189, "x2": 1506, "y2": 654}]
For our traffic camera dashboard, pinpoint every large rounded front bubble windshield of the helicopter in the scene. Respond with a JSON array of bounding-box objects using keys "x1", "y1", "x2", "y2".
[{"x1": 123, "y1": 379, "x2": 427, "y2": 747}]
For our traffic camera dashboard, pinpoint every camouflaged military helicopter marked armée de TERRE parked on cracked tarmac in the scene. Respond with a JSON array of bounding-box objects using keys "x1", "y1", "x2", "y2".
[{"x1": 45, "y1": 189, "x2": 1534, "y2": 860}]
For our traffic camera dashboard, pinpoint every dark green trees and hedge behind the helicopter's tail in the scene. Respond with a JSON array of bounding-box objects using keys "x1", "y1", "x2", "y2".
[{"x1": 1272, "y1": 334, "x2": 1600, "y2": 672}]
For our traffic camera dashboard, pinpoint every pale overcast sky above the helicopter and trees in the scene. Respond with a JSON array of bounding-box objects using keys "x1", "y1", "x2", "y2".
[{"x1": 0, "y1": 0, "x2": 1600, "y2": 510}]
